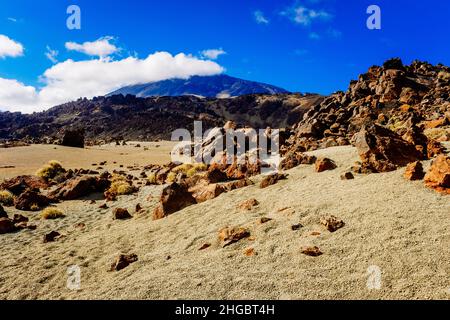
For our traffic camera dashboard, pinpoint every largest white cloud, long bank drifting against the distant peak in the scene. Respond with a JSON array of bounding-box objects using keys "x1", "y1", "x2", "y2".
[{"x1": 0, "y1": 52, "x2": 224, "y2": 113}]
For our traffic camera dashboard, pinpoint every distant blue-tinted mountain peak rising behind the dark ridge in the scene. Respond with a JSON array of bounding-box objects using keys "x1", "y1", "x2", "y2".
[{"x1": 109, "y1": 75, "x2": 288, "y2": 98}]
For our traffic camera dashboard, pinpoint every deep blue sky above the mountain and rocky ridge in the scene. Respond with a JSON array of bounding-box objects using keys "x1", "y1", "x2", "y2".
[{"x1": 0, "y1": 0, "x2": 450, "y2": 110}]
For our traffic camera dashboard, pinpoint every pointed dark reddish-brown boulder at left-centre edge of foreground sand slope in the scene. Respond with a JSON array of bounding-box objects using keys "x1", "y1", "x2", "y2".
[{"x1": 153, "y1": 182, "x2": 196, "y2": 220}]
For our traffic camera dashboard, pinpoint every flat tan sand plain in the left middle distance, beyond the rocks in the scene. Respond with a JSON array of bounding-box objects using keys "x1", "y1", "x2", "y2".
[{"x1": 0, "y1": 141, "x2": 176, "y2": 181}]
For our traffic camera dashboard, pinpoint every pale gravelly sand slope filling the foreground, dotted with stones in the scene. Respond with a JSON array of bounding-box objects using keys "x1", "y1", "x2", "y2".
[{"x1": 0, "y1": 147, "x2": 450, "y2": 299}]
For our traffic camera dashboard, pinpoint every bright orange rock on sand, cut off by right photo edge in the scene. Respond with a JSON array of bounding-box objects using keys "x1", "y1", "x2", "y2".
[{"x1": 425, "y1": 155, "x2": 450, "y2": 194}]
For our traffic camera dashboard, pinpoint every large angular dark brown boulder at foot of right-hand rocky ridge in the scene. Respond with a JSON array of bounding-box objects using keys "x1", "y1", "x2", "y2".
[{"x1": 353, "y1": 124, "x2": 423, "y2": 172}]
